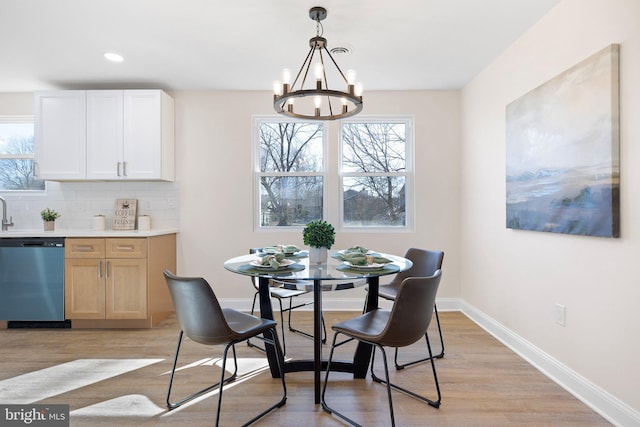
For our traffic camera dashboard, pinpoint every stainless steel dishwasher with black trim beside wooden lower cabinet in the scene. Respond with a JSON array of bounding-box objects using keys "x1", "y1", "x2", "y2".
[{"x1": 0, "y1": 236, "x2": 68, "y2": 328}]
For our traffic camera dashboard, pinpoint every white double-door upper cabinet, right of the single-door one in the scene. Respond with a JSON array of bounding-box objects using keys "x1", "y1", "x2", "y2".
[{"x1": 87, "y1": 90, "x2": 175, "y2": 181}]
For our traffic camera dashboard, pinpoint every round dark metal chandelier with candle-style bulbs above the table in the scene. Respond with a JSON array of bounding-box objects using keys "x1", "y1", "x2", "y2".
[{"x1": 273, "y1": 6, "x2": 362, "y2": 120}]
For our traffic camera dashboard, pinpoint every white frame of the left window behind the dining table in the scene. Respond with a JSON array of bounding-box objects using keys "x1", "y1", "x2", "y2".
[{"x1": 251, "y1": 115, "x2": 329, "y2": 233}]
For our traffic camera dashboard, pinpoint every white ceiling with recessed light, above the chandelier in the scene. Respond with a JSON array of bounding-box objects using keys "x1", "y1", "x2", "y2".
[{"x1": 0, "y1": 0, "x2": 559, "y2": 92}]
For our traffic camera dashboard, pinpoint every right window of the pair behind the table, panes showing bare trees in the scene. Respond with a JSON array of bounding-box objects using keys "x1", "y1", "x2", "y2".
[{"x1": 340, "y1": 119, "x2": 412, "y2": 228}]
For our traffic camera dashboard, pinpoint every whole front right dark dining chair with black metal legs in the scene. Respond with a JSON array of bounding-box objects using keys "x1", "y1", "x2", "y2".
[{"x1": 321, "y1": 270, "x2": 442, "y2": 426}]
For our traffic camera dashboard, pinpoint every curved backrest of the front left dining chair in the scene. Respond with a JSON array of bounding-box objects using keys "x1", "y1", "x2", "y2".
[{"x1": 163, "y1": 270, "x2": 235, "y2": 345}]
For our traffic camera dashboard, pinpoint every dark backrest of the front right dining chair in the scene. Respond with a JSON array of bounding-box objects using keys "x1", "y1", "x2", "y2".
[{"x1": 378, "y1": 269, "x2": 442, "y2": 347}]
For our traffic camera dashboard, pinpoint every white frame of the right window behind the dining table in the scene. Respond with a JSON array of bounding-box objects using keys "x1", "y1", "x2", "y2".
[{"x1": 338, "y1": 115, "x2": 415, "y2": 233}]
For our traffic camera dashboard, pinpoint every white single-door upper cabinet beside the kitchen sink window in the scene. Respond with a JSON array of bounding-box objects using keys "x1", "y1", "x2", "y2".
[{"x1": 34, "y1": 90, "x2": 86, "y2": 180}]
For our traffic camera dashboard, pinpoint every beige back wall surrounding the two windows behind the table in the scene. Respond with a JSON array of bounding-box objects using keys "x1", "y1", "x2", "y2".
[{"x1": 174, "y1": 91, "x2": 460, "y2": 308}]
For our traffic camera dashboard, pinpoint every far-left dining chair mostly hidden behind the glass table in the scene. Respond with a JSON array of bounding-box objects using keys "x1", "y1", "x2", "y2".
[{"x1": 247, "y1": 248, "x2": 327, "y2": 354}]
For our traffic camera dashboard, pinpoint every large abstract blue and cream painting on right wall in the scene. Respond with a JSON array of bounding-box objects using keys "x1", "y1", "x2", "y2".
[{"x1": 506, "y1": 44, "x2": 620, "y2": 237}]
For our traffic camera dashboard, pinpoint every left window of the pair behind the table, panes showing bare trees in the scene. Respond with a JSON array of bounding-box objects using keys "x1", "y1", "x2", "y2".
[{"x1": 255, "y1": 119, "x2": 325, "y2": 228}]
